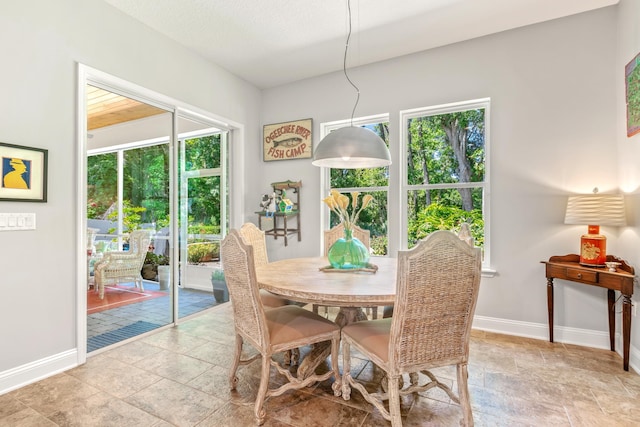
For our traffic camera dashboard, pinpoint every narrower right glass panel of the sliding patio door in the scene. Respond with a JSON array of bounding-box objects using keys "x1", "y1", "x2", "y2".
[{"x1": 178, "y1": 118, "x2": 229, "y2": 318}]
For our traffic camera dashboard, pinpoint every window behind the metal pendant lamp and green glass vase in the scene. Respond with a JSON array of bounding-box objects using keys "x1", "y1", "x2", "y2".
[{"x1": 322, "y1": 114, "x2": 389, "y2": 255}]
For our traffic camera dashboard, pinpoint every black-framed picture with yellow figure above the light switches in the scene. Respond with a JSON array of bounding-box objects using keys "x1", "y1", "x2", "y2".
[{"x1": 0, "y1": 142, "x2": 47, "y2": 202}]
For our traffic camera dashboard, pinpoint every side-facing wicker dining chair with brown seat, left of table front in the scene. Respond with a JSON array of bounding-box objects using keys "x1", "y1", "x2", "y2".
[{"x1": 221, "y1": 229, "x2": 341, "y2": 425}]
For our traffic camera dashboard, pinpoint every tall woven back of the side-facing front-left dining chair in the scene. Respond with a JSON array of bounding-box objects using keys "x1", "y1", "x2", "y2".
[{"x1": 220, "y1": 229, "x2": 269, "y2": 349}]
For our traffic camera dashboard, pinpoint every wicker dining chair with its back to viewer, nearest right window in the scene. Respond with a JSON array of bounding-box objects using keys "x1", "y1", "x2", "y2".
[{"x1": 342, "y1": 230, "x2": 481, "y2": 427}]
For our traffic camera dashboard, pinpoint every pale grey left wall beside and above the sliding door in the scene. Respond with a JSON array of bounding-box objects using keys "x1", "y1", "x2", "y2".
[{"x1": 0, "y1": 0, "x2": 260, "y2": 392}]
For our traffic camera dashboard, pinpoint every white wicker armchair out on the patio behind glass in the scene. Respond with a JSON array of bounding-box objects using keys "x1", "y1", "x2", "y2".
[{"x1": 93, "y1": 230, "x2": 151, "y2": 299}]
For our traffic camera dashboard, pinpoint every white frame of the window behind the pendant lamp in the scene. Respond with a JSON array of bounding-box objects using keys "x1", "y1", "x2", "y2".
[{"x1": 319, "y1": 113, "x2": 393, "y2": 253}]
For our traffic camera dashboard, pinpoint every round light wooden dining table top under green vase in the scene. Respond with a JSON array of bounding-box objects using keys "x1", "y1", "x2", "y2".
[{"x1": 256, "y1": 257, "x2": 397, "y2": 307}]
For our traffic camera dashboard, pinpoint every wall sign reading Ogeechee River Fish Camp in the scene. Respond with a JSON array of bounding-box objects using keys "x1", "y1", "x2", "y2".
[{"x1": 262, "y1": 119, "x2": 313, "y2": 162}]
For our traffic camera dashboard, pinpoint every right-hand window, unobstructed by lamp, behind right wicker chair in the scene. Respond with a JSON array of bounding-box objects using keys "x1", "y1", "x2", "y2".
[{"x1": 400, "y1": 99, "x2": 489, "y2": 266}]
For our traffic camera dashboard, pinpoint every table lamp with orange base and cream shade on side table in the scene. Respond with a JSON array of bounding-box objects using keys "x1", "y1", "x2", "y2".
[{"x1": 564, "y1": 188, "x2": 627, "y2": 267}]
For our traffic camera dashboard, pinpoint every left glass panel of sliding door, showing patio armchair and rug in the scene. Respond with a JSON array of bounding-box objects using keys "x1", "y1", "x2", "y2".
[{"x1": 86, "y1": 85, "x2": 174, "y2": 353}]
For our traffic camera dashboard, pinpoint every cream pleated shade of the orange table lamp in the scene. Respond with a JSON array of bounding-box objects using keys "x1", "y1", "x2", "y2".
[{"x1": 564, "y1": 194, "x2": 627, "y2": 227}]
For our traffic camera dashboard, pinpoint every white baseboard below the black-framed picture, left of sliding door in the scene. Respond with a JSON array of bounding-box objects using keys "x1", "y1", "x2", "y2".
[{"x1": 0, "y1": 349, "x2": 78, "y2": 395}]
